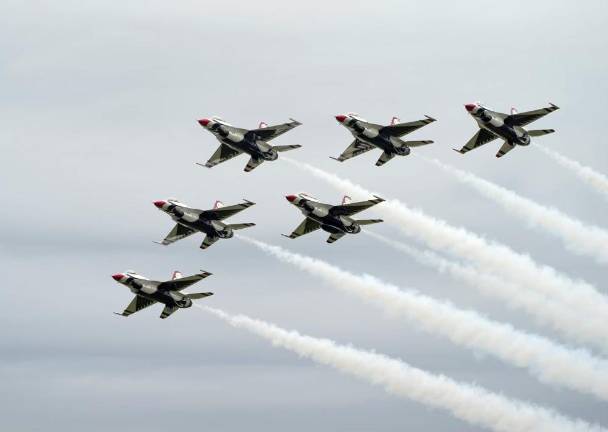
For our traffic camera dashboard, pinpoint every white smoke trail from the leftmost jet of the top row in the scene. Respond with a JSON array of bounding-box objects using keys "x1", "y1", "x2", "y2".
[{"x1": 283, "y1": 157, "x2": 608, "y2": 344}]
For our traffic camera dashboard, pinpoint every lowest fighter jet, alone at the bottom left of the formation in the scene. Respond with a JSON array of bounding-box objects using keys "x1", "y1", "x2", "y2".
[{"x1": 112, "y1": 270, "x2": 213, "y2": 319}]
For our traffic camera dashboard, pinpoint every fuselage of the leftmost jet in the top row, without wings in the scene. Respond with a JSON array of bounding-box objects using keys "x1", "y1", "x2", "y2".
[{"x1": 201, "y1": 120, "x2": 279, "y2": 161}]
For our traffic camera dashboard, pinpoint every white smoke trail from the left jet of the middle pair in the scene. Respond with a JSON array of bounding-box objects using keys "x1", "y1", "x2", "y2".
[{"x1": 239, "y1": 236, "x2": 608, "y2": 400}]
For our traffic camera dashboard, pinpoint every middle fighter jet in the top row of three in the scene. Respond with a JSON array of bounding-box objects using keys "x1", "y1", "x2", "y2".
[{"x1": 330, "y1": 113, "x2": 435, "y2": 166}]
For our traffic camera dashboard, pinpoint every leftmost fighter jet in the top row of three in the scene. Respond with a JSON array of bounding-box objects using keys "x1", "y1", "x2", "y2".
[{"x1": 197, "y1": 117, "x2": 302, "y2": 172}]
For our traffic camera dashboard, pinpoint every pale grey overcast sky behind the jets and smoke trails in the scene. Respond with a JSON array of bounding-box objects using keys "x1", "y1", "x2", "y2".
[{"x1": 0, "y1": 0, "x2": 608, "y2": 432}]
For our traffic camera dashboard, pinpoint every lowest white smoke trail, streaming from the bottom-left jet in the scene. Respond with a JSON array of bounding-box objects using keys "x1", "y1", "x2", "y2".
[{"x1": 204, "y1": 307, "x2": 604, "y2": 432}]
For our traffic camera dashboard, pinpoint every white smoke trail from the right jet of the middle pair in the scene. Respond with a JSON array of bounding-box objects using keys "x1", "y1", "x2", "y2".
[{"x1": 364, "y1": 231, "x2": 608, "y2": 352}]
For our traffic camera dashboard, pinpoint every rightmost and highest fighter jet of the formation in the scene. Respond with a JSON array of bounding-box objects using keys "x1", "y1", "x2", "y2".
[{"x1": 454, "y1": 102, "x2": 559, "y2": 157}]
